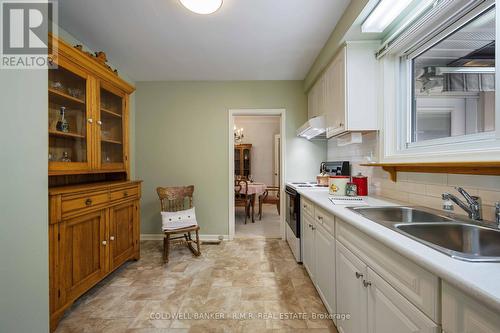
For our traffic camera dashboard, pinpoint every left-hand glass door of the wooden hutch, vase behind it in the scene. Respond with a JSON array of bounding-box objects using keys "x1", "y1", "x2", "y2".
[{"x1": 48, "y1": 64, "x2": 91, "y2": 172}]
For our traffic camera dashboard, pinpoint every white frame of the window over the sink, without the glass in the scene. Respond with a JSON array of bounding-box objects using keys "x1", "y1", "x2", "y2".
[{"x1": 379, "y1": 0, "x2": 500, "y2": 163}]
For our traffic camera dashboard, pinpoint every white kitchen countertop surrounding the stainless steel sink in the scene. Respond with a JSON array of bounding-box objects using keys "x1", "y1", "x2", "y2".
[{"x1": 297, "y1": 188, "x2": 500, "y2": 311}]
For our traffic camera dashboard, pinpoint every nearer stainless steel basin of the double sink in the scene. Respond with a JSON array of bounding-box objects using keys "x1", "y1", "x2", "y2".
[{"x1": 395, "y1": 223, "x2": 500, "y2": 261}]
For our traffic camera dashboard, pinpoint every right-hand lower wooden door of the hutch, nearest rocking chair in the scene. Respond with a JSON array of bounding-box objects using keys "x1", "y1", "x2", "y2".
[{"x1": 109, "y1": 201, "x2": 138, "y2": 270}]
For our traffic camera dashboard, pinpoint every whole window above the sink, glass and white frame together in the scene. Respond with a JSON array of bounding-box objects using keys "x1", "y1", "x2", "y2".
[{"x1": 377, "y1": 0, "x2": 500, "y2": 163}]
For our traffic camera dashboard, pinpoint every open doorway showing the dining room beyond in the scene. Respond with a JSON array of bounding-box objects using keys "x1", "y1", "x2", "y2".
[{"x1": 228, "y1": 109, "x2": 285, "y2": 239}]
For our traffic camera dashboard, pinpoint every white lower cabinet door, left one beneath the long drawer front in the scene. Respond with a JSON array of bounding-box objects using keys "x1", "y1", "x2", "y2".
[{"x1": 336, "y1": 241, "x2": 368, "y2": 333}]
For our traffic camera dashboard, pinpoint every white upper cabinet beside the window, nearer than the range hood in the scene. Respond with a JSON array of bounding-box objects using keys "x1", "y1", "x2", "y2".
[{"x1": 324, "y1": 41, "x2": 379, "y2": 138}]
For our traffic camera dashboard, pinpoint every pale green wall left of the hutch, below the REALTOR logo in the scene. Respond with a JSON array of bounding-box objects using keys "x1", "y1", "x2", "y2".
[{"x1": 0, "y1": 70, "x2": 49, "y2": 333}]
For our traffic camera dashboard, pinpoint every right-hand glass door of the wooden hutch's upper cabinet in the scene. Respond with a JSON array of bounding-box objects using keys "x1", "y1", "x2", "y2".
[{"x1": 98, "y1": 84, "x2": 125, "y2": 170}]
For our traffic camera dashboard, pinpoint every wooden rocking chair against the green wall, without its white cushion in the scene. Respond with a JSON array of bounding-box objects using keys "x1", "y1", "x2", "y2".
[{"x1": 156, "y1": 185, "x2": 201, "y2": 263}]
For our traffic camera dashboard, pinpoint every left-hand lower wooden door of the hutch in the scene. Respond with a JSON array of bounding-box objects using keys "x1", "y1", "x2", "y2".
[{"x1": 59, "y1": 209, "x2": 107, "y2": 299}]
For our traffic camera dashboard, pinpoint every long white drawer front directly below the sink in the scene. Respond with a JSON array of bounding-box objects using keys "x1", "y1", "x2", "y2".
[{"x1": 336, "y1": 218, "x2": 441, "y2": 323}]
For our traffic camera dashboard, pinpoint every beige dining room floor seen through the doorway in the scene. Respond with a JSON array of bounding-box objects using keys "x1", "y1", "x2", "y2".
[{"x1": 234, "y1": 205, "x2": 281, "y2": 238}]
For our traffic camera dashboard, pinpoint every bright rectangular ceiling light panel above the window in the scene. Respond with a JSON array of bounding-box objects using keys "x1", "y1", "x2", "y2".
[{"x1": 361, "y1": 0, "x2": 413, "y2": 32}]
